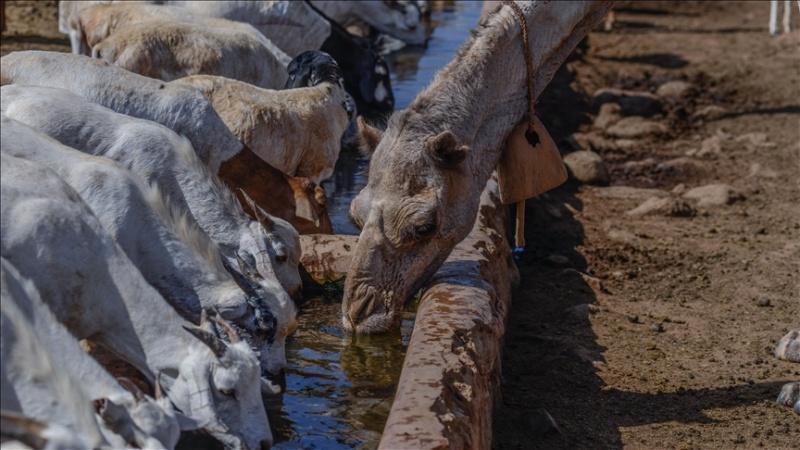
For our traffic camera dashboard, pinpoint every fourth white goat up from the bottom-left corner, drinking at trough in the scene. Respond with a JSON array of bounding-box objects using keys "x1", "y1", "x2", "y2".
[{"x1": 0, "y1": 85, "x2": 301, "y2": 373}]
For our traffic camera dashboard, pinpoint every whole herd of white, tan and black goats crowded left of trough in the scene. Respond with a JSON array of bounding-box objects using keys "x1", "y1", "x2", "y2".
[{"x1": 0, "y1": 1, "x2": 426, "y2": 449}]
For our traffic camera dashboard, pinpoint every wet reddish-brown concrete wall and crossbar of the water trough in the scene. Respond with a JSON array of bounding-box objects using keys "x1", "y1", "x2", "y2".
[{"x1": 301, "y1": 179, "x2": 518, "y2": 449}]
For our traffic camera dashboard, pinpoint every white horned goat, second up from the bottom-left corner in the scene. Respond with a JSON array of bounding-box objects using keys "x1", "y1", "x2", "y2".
[{"x1": 0, "y1": 152, "x2": 272, "y2": 448}]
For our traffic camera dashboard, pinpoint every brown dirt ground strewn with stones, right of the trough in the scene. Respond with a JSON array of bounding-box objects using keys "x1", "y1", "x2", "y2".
[{"x1": 494, "y1": 2, "x2": 800, "y2": 449}]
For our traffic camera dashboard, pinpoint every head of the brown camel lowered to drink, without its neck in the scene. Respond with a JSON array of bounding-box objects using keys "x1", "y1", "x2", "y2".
[{"x1": 342, "y1": 108, "x2": 483, "y2": 333}]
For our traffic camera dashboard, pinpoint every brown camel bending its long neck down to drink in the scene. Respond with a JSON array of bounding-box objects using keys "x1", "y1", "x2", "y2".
[{"x1": 342, "y1": 1, "x2": 611, "y2": 333}]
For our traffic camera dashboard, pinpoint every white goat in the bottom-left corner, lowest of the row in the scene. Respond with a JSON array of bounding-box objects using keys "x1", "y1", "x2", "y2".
[{"x1": 0, "y1": 258, "x2": 180, "y2": 449}]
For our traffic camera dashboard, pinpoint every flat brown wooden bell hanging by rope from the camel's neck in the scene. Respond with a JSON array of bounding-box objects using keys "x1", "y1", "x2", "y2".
[{"x1": 497, "y1": 1, "x2": 567, "y2": 250}]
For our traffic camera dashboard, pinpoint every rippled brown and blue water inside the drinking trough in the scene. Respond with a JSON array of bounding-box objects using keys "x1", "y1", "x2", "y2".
[{"x1": 276, "y1": 1, "x2": 481, "y2": 449}]
